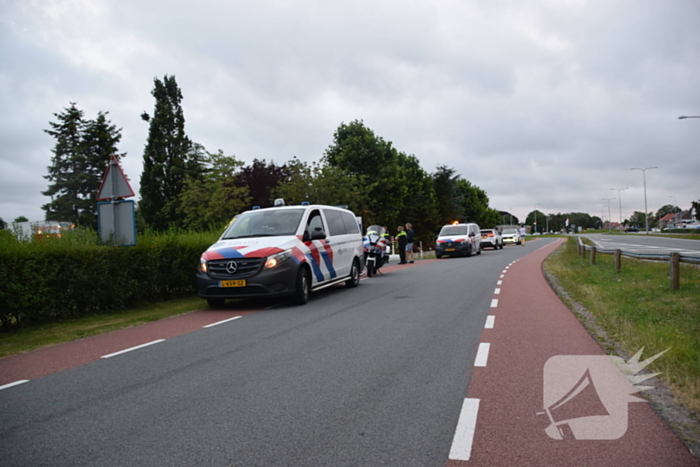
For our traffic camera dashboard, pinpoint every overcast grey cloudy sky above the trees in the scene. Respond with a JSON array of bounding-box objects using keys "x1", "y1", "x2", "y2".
[{"x1": 0, "y1": 0, "x2": 700, "y2": 227}]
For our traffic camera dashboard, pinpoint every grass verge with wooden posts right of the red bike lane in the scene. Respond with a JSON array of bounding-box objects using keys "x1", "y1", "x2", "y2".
[{"x1": 544, "y1": 238, "x2": 700, "y2": 414}]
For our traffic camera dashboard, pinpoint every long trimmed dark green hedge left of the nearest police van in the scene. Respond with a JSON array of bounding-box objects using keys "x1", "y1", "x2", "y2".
[{"x1": 0, "y1": 231, "x2": 218, "y2": 330}]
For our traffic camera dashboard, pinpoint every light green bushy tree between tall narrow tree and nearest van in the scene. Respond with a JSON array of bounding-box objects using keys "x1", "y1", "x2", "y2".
[{"x1": 173, "y1": 150, "x2": 250, "y2": 230}]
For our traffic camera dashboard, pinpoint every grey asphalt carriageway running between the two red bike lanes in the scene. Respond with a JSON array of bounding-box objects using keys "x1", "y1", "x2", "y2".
[{"x1": 0, "y1": 239, "x2": 551, "y2": 467}]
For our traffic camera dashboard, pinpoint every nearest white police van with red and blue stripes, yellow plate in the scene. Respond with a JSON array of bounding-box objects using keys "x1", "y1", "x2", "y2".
[{"x1": 197, "y1": 200, "x2": 363, "y2": 307}]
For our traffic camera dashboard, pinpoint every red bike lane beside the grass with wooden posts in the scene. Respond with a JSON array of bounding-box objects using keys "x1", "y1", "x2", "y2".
[{"x1": 447, "y1": 241, "x2": 700, "y2": 467}]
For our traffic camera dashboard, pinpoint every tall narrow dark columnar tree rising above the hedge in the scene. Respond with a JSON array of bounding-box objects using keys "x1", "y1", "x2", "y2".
[{"x1": 139, "y1": 75, "x2": 203, "y2": 230}]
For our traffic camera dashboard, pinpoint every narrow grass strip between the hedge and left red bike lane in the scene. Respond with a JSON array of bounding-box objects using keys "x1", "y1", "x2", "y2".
[{"x1": 0, "y1": 296, "x2": 207, "y2": 357}]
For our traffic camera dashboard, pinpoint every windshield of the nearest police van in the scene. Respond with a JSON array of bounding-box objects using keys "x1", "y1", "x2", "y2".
[{"x1": 221, "y1": 209, "x2": 305, "y2": 240}]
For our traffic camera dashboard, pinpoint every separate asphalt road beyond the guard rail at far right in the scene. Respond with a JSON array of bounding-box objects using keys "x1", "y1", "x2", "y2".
[{"x1": 586, "y1": 234, "x2": 700, "y2": 255}]
